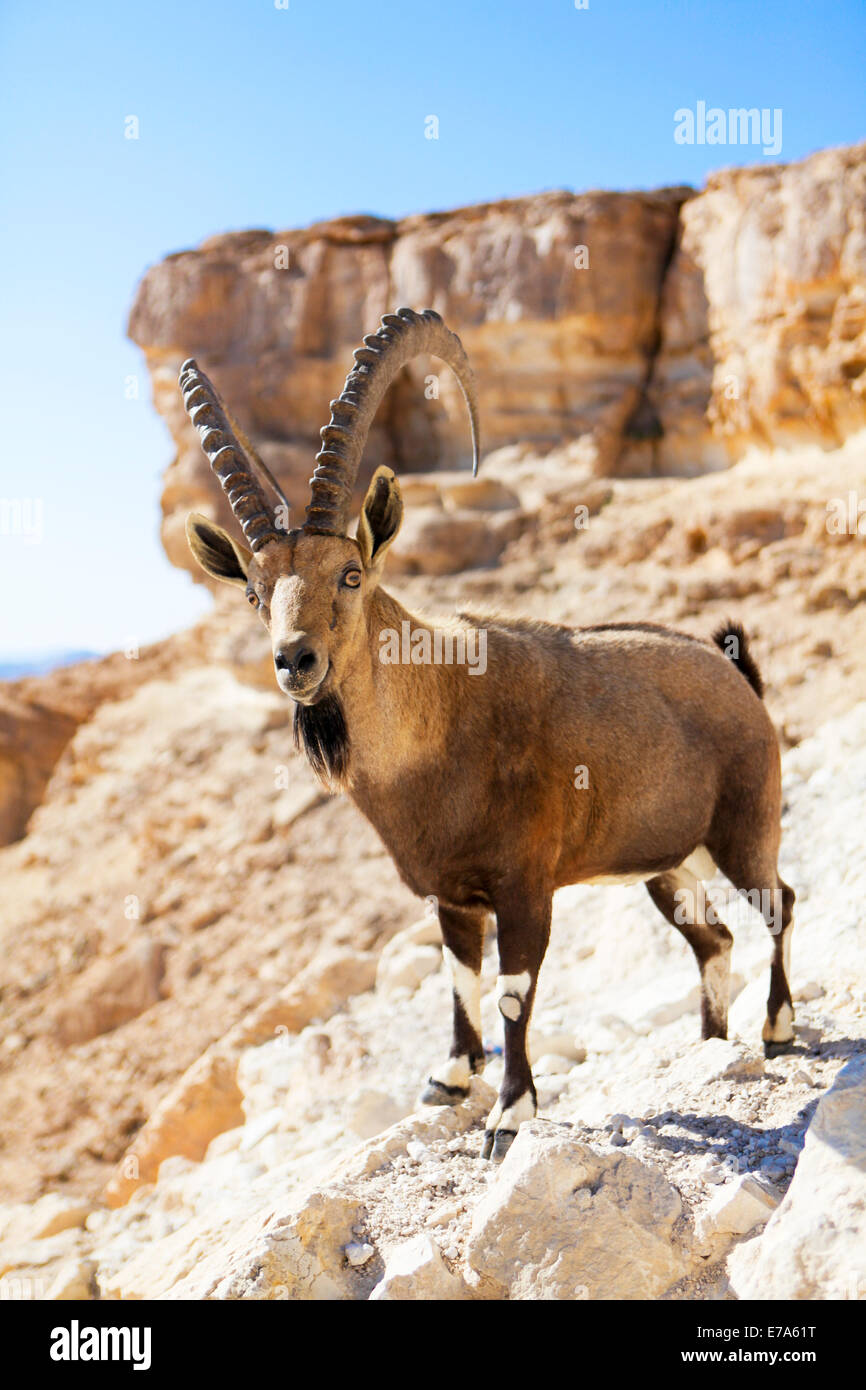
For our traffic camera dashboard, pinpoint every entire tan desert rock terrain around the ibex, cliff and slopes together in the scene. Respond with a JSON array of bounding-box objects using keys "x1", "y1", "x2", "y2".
[{"x1": 0, "y1": 135, "x2": 866, "y2": 1301}]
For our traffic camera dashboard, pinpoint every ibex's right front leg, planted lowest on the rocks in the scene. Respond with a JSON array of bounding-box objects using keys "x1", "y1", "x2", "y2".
[{"x1": 481, "y1": 894, "x2": 550, "y2": 1161}]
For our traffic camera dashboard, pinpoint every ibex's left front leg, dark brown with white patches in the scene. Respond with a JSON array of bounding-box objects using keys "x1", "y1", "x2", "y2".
[{"x1": 421, "y1": 906, "x2": 487, "y2": 1105}]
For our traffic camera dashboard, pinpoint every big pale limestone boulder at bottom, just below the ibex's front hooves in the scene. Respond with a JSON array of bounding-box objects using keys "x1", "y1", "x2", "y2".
[{"x1": 467, "y1": 1120, "x2": 689, "y2": 1300}]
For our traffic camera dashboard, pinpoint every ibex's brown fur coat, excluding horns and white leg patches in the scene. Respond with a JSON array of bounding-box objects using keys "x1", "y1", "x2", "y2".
[{"x1": 190, "y1": 470, "x2": 794, "y2": 1154}]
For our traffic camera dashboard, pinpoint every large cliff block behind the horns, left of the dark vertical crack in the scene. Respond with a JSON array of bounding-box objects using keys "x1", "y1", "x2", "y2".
[{"x1": 129, "y1": 189, "x2": 688, "y2": 566}]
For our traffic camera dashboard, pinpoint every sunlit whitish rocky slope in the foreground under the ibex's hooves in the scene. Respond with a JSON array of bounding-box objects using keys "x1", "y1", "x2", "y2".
[{"x1": 0, "y1": 703, "x2": 866, "y2": 1300}]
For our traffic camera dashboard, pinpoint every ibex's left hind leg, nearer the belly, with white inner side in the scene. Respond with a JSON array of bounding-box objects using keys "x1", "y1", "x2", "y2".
[{"x1": 646, "y1": 865, "x2": 734, "y2": 1038}]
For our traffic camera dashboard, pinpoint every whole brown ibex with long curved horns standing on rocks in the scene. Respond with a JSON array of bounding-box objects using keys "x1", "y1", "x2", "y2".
[{"x1": 181, "y1": 309, "x2": 794, "y2": 1159}]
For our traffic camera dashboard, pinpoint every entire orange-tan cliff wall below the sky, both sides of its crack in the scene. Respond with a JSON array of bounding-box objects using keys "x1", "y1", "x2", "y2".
[{"x1": 129, "y1": 146, "x2": 866, "y2": 578}]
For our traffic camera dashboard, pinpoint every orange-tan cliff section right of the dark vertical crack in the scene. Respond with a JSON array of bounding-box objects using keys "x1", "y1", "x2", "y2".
[{"x1": 648, "y1": 145, "x2": 866, "y2": 471}]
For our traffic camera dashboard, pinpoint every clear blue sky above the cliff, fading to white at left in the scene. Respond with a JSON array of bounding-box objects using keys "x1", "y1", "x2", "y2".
[{"x1": 0, "y1": 0, "x2": 866, "y2": 657}]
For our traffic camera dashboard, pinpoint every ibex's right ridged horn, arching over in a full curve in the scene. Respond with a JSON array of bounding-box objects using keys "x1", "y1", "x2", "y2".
[{"x1": 303, "y1": 309, "x2": 478, "y2": 535}]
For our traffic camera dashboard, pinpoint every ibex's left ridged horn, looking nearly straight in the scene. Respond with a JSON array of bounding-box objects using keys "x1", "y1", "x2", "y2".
[{"x1": 178, "y1": 357, "x2": 285, "y2": 550}]
